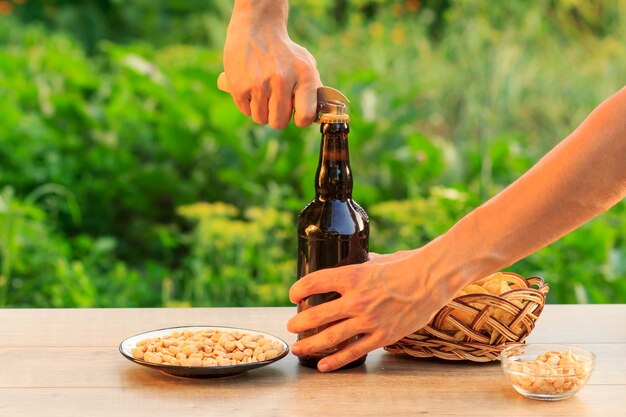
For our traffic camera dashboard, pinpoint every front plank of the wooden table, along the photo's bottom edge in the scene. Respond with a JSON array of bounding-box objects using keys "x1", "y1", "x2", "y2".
[{"x1": 0, "y1": 384, "x2": 626, "y2": 417}]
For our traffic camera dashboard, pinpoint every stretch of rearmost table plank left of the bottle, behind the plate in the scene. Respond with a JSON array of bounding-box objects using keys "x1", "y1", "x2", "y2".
[{"x1": 0, "y1": 307, "x2": 296, "y2": 346}]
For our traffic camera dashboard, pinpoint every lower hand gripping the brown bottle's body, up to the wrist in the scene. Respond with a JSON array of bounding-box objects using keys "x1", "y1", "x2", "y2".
[{"x1": 287, "y1": 249, "x2": 452, "y2": 372}]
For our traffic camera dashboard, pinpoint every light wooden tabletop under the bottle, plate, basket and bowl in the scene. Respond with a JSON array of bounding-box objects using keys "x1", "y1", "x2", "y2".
[{"x1": 0, "y1": 305, "x2": 626, "y2": 417}]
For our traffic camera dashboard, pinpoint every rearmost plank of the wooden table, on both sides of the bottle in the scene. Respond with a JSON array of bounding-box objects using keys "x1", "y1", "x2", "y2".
[{"x1": 0, "y1": 304, "x2": 626, "y2": 346}]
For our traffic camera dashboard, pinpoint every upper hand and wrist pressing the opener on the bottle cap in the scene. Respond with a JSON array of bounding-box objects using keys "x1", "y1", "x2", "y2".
[{"x1": 224, "y1": 0, "x2": 321, "y2": 129}]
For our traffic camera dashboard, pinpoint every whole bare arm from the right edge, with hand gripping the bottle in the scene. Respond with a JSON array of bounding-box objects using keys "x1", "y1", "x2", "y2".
[{"x1": 287, "y1": 88, "x2": 626, "y2": 371}]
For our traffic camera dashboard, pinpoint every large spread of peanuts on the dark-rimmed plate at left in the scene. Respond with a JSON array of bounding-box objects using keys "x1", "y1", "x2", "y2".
[{"x1": 131, "y1": 329, "x2": 283, "y2": 366}]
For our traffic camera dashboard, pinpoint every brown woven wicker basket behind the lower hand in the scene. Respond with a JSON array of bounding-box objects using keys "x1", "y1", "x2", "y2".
[{"x1": 385, "y1": 272, "x2": 549, "y2": 362}]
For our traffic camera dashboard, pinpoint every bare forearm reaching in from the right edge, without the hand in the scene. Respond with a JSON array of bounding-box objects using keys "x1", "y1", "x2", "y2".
[{"x1": 424, "y1": 88, "x2": 626, "y2": 296}]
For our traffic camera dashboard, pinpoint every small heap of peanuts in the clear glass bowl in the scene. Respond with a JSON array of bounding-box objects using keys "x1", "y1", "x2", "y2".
[{"x1": 509, "y1": 349, "x2": 593, "y2": 394}]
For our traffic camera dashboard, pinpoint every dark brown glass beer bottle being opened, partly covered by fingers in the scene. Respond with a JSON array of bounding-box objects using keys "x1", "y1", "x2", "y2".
[{"x1": 298, "y1": 119, "x2": 369, "y2": 368}]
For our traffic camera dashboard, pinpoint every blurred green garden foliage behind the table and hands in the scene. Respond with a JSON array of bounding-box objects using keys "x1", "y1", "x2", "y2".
[{"x1": 0, "y1": 0, "x2": 626, "y2": 307}]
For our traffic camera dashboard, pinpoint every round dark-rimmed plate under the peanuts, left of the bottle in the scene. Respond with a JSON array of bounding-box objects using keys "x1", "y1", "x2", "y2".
[{"x1": 120, "y1": 326, "x2": 289, "y2": 378}]
